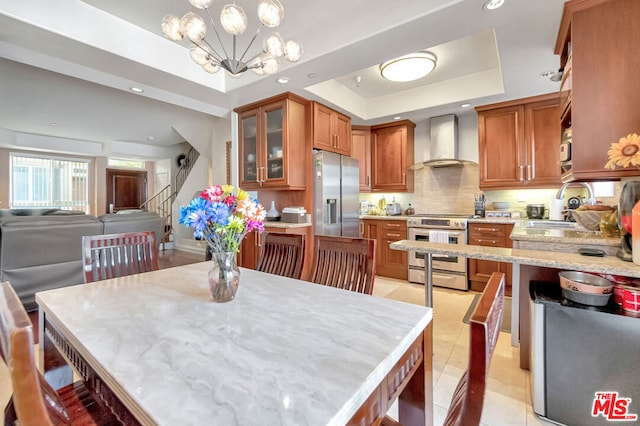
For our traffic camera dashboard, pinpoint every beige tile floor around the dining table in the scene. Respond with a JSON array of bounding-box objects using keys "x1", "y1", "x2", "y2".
[{"x1": 0, "y1": 277, "x2": 549, "y2": 426}]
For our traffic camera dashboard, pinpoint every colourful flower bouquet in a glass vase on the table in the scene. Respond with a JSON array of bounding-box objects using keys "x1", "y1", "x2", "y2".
[{"x1": 180, "y1": 185, "x2": 266, "y2": 302}]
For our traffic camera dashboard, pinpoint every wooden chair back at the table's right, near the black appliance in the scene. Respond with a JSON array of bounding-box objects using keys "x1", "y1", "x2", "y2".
[{"x1": 444, "y1": 272, "x2": 505, "y2": 426}]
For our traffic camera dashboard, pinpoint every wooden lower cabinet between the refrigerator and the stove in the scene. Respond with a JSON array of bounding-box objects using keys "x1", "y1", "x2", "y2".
[{"x1": 360, "y1": 219, "x2": 408, "y2": 280}]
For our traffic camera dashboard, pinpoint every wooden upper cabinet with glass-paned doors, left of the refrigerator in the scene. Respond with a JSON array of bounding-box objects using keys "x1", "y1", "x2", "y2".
[{"x1": 235, "y1": 93, "x2": 310, "y2": 190}]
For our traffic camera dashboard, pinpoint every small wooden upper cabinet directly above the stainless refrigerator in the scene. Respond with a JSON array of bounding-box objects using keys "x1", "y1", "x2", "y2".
[{"x1": 312, "y1": 102, "x2": 351, "y2": 156}]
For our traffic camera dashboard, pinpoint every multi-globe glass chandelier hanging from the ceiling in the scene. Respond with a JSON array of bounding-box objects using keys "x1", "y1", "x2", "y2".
[{"x1": 162, "y1": 0, "x2": 302, "y2": 76}]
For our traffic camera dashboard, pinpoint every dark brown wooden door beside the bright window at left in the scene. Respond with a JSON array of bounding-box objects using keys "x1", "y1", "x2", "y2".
[{"x1": 106, "y1": 169, "x2": 147, "y2": 213}]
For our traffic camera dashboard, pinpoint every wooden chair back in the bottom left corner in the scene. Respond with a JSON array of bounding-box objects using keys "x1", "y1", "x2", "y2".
[{"x1": 0, "y1": 282, "x2": 69, "y2": 425}]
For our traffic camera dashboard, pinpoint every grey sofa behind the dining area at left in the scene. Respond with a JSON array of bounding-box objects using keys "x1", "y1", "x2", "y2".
[{"x1": 0, "y1": 209, "x2": 165, "y2": 311}]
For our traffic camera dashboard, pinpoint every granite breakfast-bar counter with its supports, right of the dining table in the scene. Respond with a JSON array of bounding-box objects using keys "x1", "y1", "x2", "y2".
[{"x1": 391, "y1": 240, "x2": 640, "y2": 369}]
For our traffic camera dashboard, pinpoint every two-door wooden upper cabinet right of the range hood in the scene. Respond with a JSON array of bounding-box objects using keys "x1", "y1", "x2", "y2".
[{"x1": 476, "y1": 93, "x2": 561, "y2": 189}]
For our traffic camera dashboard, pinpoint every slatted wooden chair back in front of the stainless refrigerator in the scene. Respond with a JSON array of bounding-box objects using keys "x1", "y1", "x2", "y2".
[{"x1": 311, "y1": 235, "x2": 376, "y2": 294}]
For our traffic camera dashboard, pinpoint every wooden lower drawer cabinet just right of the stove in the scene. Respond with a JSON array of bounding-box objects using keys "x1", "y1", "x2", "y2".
[{"x1": 469, "y1": 223, "x2": 513, "y2": 297}]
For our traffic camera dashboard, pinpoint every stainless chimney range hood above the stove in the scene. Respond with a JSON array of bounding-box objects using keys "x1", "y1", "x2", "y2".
[{"x1": 409, "y1": 114, "x2": 476, "y2": 170}]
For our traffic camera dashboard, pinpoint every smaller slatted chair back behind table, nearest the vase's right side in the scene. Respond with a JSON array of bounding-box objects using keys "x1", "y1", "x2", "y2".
[{"x1": 257, "y1": 232, "x2": 304, "y2": 279}]
